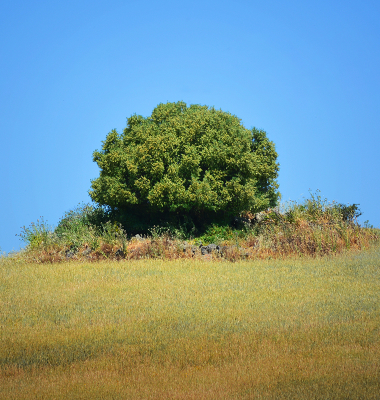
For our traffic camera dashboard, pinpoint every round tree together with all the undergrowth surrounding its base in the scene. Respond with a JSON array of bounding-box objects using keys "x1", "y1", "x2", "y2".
[{"x1": 10, "y1": 102, "x2": 379, "y2": 262}]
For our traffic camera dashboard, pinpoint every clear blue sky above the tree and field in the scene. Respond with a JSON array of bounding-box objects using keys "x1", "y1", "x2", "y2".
[{"x1": 0, "y1": 0, "x2": 380, "y2": 252}]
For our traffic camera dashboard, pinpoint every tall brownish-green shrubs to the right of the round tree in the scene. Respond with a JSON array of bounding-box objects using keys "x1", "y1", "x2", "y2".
[{"x1": 246, "y1": 191, "x2": 379, "y2": 257}]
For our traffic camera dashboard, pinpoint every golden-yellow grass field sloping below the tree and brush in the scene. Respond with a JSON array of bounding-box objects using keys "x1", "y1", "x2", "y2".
[{"x1": 0, "y1": 244, "x2": 380, "y2": 399}]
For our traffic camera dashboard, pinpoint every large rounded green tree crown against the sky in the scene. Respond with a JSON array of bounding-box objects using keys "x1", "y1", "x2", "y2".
[{"x1": 89, "y1": 102, "x2": 279, "y2": 233}]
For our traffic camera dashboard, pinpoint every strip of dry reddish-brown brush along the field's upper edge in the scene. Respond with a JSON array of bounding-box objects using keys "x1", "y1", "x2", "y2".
[{"x1": 14, "y1": 220, "x2": 379, "y2": 263}]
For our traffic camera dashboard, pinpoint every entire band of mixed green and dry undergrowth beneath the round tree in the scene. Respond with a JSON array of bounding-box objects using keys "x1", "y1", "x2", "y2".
[{"x1": 14, "y1": 192, "x2": 379, "y2": 262}]
